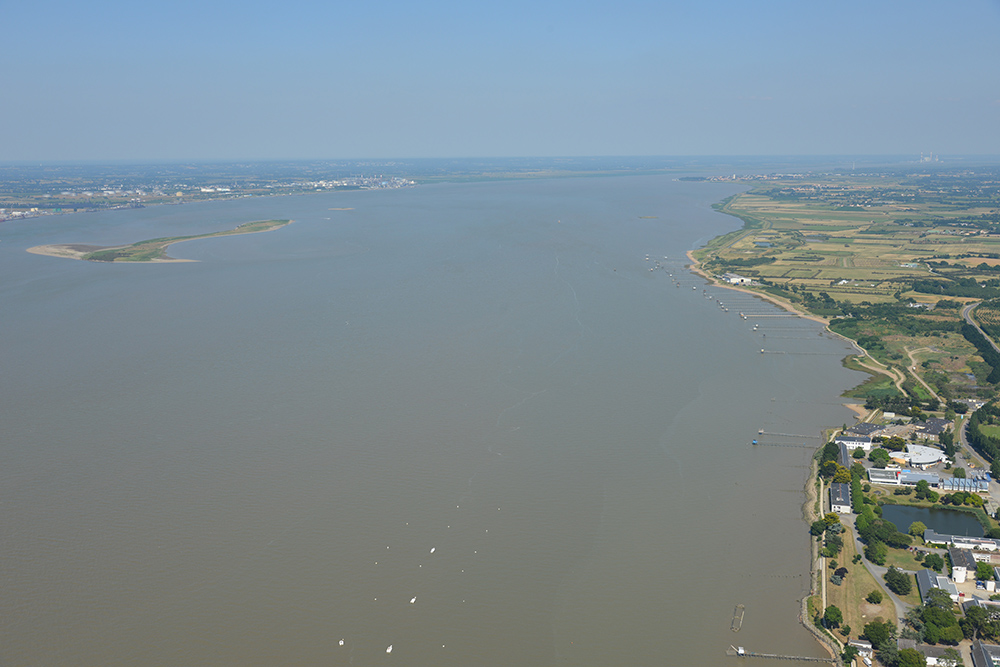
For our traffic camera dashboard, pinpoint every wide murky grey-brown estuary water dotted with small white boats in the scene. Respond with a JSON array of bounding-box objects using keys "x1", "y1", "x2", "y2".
[{"x1": 0, "y1": 176, "x2": 862, "y2": 667}]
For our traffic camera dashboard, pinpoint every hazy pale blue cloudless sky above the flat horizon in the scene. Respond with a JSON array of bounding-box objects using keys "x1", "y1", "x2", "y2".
[{"x1": 0, "y1": 0, "x2": 1000, "y2": 161}]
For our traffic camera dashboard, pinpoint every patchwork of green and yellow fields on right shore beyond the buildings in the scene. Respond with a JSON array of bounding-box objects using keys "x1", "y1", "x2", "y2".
[{"x1": 694, "y1": 171, "x2": 1000, "y2": 410}]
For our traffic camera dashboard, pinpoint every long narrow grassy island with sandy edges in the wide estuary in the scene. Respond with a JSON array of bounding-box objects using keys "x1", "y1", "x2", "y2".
[{"x1": 28, "y1": 220, "x2": 292, "y2": 263}]
